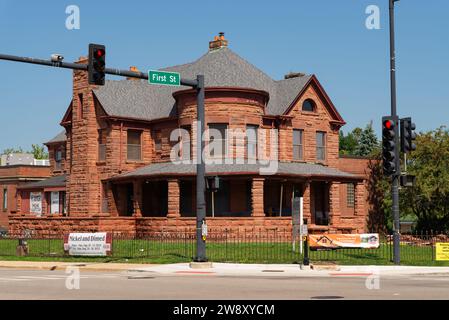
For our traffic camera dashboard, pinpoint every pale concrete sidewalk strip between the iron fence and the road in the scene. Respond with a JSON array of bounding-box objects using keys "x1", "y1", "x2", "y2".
[{"x1": 0, "y1": 261, "x2": 449, "y2": 277}]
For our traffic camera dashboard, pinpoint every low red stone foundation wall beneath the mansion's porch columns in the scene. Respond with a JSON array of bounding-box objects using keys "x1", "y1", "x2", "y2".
[{"x1": 9, "y1": 217, "x2": 364, "y2": 236}]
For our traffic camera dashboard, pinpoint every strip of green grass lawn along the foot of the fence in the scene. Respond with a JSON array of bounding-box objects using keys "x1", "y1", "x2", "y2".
[{"x1": 0, "y1": 239, "x2": 449, "y2": 266}]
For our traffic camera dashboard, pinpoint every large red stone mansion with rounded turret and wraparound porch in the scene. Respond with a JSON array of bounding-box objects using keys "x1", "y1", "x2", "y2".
[{"x1": 9, "y1": 37, "x2": 368, "y2": 233}]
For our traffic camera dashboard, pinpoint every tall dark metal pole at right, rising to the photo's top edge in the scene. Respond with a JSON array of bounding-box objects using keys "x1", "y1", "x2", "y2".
[{"x1": 389, "y1": 0, "x2": 401, "y2": 265}]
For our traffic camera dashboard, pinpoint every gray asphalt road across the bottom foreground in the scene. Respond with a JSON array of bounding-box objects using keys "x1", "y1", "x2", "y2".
[{"x1": 0, "y1": 269, "x2": 449, "y2": 300}]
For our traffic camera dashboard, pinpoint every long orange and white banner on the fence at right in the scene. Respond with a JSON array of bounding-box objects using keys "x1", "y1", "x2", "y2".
[{"x1": 309, "y1": 233, "x2": 379, "y2": 249}]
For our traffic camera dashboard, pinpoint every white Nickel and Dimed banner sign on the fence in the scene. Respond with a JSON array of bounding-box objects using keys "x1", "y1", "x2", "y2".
[{"x1": 64, "y1": 232, "x2": 112, "y2": 256}]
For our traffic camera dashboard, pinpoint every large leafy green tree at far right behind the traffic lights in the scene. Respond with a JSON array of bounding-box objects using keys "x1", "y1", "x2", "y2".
[{"x1": 368, "y1": 127, "x2": 449, "y2": 232}]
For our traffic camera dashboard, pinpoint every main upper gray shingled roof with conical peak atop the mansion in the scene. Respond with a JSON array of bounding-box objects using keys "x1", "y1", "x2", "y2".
[{"x1": 94, "y1": 47, "x2": 311, "y2": 120}]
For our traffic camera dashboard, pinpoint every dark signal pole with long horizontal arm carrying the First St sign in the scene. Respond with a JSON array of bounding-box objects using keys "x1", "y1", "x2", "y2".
[{"x1": 0, "y1": 49, "x2": 207, "y2": 262}]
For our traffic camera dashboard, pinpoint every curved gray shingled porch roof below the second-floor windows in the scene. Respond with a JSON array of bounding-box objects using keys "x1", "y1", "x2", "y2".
[{"x1": 111, "y1": 162, "x2": 361, "y2": 180}]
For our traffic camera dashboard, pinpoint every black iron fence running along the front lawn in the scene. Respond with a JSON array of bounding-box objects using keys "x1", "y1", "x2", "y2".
[{"x1": 0, "y1": 229, "x2": 449, "y2": 265}]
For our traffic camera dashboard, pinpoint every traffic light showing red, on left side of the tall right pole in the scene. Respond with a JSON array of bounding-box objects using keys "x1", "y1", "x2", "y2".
[{"x1": 382, "y1": 116, "x2": 399, "y2": 176}]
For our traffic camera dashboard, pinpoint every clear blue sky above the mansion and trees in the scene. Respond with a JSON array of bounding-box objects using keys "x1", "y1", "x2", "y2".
[{"x1": 0, "y1": 0, "x2": 449, "y2": 151}]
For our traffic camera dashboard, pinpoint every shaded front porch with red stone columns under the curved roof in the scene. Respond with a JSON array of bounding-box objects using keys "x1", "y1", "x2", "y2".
[{"x1": 108, "y1": 175, "x2": 365, "y2": 233}]
